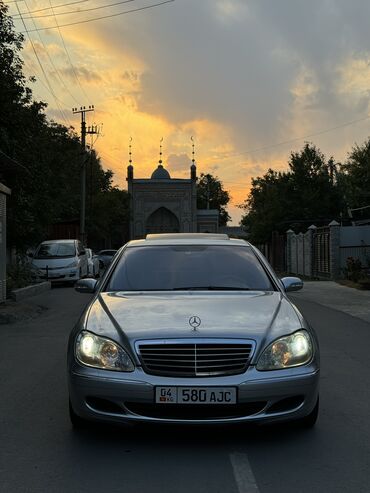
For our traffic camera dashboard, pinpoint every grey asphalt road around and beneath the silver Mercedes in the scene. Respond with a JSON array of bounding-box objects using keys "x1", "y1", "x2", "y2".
[{"x1": 0, "y1": 288, "x2": 370, "y2": 493}]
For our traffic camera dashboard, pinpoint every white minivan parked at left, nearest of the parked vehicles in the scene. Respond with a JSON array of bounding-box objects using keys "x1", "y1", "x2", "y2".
[{"x1": 31, "y1": 240, "x2": 88, "y2": 282}]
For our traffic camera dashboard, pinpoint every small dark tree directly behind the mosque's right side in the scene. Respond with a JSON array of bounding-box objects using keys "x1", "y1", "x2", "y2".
[{"x1": 197, "y1": 173, "x2": 231, "y2": 226}]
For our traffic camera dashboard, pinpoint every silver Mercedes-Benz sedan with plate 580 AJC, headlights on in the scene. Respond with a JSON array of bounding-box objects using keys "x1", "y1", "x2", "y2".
[{"x1": 68, "y1": 234, "x2": 319, "y2": 427}]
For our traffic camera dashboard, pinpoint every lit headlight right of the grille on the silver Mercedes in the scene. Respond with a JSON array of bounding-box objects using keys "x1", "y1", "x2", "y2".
[{"x1": 256, "y1": 330, "x2": 313, "y2": 371}]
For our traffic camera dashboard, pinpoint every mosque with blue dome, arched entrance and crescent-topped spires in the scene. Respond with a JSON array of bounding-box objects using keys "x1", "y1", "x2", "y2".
[{"x1": 127, "y1": 139, "x2": 219, "y2": 240}]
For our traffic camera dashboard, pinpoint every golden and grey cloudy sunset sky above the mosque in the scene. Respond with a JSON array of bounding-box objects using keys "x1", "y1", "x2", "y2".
[{"x1": 5, "y1": 0, "x2": 370, "y2": 224}]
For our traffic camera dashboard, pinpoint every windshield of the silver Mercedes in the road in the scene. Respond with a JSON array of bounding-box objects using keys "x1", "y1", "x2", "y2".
[{"x1": 106, "y1": 245, "x2": 274, "y2": 291}]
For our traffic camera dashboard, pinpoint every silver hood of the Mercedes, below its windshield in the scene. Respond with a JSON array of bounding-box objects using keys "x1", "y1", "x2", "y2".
[{"x1": 86, "y1": 291, "x2": 303, "y2": 345}]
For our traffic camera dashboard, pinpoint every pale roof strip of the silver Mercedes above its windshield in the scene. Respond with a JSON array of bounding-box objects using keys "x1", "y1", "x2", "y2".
[{"x1": 127, "y1": 233, "x2": 250, "y2": 247}]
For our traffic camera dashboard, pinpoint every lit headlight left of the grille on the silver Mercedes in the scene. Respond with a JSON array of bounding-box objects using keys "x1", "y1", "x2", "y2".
[{"x1": 76, "y1": 331, "x2": 135, "y2": 371}]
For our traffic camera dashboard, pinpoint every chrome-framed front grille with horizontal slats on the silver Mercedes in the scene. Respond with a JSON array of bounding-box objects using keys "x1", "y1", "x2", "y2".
[{"x1": 136, "y1": 339, "x2": 254, "y2": 377}]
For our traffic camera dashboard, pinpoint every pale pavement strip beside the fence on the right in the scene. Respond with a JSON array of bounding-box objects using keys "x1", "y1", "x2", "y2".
[{"x1": 292, "y1": 281, "x2": 370, "y2": 323}]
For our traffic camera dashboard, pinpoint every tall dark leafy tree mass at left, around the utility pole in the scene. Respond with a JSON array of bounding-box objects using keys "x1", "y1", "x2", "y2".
[{"x1": 0, "y1": 0, "x2": 128, "y2": 251}]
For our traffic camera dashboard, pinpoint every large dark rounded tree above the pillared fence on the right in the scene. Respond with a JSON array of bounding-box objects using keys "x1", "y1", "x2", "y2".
[{"x1": 240, "y1": 143, "x2": 344, "y2": 243}]
